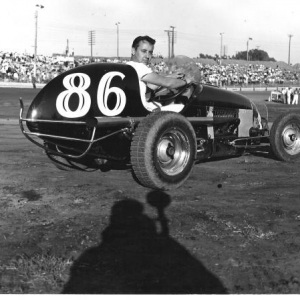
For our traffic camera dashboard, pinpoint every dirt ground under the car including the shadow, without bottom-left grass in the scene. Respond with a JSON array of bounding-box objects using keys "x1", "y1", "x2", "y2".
[{"x1": 0, "y1": 89, "x2": 300, "y2": 294}]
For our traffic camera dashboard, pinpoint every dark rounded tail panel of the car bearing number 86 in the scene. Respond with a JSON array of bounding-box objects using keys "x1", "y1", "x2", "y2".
[{"x1": 27, "y1": 63, "x2": 147, "y2": 121}]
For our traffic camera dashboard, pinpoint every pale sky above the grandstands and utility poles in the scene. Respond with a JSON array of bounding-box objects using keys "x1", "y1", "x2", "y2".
[{"x1": 0, "y1": 0, "x2": 300, "y2": 64}]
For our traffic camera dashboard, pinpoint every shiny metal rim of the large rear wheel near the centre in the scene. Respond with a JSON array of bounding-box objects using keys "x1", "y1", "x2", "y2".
[{"x1": 157, "y1": 129, "x2": 190, "y2": 176}]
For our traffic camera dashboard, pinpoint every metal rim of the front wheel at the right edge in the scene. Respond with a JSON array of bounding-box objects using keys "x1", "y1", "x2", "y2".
[{"x1": 282, "y1": 124, "x2": 300, "y2": 155}]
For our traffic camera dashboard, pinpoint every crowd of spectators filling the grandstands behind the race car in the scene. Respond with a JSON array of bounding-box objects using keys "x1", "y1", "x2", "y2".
[{"x1": 0, "y1": 51, "x2": 298, "y2": 86}]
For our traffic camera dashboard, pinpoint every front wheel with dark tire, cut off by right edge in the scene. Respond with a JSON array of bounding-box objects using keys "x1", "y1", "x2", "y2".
[{"x1": 270, "y1": 112, "x2": 300, "y2": 162}]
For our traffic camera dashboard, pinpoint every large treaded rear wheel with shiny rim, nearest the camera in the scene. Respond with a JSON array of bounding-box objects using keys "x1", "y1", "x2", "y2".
[{"x1": 131, "y1": 111, "x2": 197, "y2": 190}]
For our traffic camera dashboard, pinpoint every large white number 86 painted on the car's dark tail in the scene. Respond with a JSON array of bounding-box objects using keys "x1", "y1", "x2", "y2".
[{"x1": 56, "y1": 72, "x2": 126, "y2": 118}]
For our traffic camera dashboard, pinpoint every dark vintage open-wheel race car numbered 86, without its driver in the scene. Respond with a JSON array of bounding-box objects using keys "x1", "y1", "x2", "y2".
[{"x1": 20, "y1": 58, "x2": 300, "y2": 190}]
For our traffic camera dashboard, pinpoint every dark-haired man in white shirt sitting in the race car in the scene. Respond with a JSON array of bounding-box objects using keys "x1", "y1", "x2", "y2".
[{"x1": 127, "y1": 35, "x2": 193, "y2": 111}]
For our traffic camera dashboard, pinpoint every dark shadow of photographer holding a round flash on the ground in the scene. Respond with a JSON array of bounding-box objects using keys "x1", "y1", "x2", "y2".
[{"x1": 63, "y1": 192, "x2": 226, "y2": 294}]
